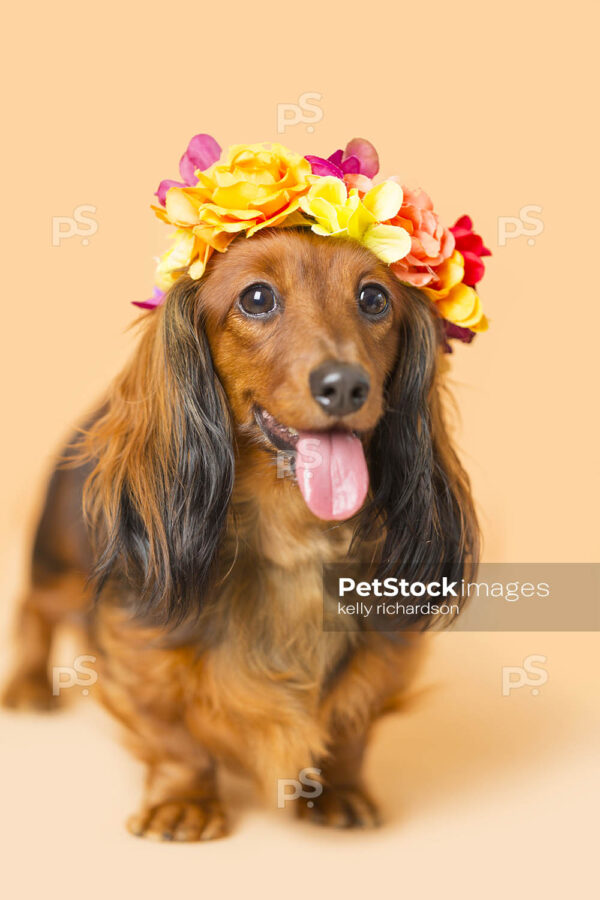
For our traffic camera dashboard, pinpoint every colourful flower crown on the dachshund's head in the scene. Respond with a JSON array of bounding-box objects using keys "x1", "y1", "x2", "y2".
[{"x1": 136, "y1": 134, "x2": 490, "y2": 343}]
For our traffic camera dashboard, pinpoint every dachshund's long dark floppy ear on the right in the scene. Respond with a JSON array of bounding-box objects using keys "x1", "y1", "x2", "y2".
[{"x1": 359, "y1": 288, "x2": 479, "y2": 630}]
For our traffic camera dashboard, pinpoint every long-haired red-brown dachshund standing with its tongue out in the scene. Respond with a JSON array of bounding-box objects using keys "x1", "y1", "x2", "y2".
[{"x1": 4, "y1": 228, "x2": 478, "y2": 841}]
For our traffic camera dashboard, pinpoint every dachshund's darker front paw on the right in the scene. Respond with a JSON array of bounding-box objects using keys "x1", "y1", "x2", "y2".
[{"x1": 298, "y1": 785, "x2": 380, "y2": 828}]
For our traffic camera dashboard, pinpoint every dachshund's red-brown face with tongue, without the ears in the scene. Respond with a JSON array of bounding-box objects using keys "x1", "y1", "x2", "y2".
[{"x1": 204, "y1": 230, "x2": 406, "y2": 520}]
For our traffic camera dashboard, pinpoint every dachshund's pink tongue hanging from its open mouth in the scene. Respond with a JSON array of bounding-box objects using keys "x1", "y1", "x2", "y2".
[{"x1": 296, "y1": 431, "x2": 369, "y2": 520}]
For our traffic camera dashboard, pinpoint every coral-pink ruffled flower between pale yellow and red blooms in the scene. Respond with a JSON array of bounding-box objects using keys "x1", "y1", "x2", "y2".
[{"x1": 391, "y1": 187, "x2": 455, "y2": 287}]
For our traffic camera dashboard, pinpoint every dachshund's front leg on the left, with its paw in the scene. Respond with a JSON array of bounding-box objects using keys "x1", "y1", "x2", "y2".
[{"x1": 94, "y1": 593, "x2": 227, "y2": 841}]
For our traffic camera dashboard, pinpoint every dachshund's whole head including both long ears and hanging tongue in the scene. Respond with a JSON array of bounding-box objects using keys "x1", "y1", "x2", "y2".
[{"x1": 88, "y1": 229, "x2": 476, "y2": 620}]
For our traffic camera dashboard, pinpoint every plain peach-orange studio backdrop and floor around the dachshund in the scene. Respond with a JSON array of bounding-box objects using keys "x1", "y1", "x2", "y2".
[{"x1": 0, "y1": 0, "x2": 600, "y2": 897}]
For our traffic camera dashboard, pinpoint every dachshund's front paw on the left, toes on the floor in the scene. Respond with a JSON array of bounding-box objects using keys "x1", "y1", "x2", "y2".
[{"x1": 127, "y1": 799, "x2": 229, "y2": 841}]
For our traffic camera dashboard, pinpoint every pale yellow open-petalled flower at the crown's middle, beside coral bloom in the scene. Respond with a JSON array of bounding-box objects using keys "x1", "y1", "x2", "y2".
[{"x1": 300, "y1": 176, "x2": 411, "y2": 264}]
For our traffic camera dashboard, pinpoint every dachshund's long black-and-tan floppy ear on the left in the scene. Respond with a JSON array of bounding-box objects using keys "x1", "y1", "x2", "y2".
[{"x1": 83, "y1": 278, "x2": 234, "y2": 625}]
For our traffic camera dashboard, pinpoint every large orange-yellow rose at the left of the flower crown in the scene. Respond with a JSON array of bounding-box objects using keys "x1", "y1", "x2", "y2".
[{"x1": 154, "y1": 144, "x2": 312, "y2": 287}]
